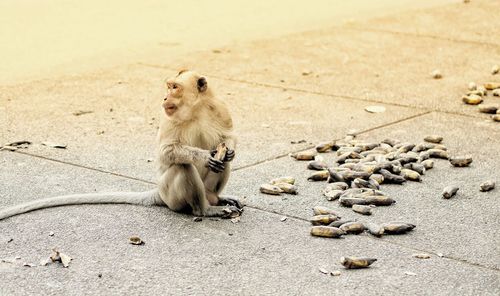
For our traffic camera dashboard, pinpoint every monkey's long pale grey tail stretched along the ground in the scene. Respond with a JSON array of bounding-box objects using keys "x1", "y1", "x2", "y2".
[{"x1": 0, "y1": 189, "x2": 161, "y2": 220}]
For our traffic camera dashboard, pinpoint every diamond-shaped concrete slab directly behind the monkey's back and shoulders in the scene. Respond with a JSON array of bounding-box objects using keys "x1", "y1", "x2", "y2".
[{"x1": 0, "y1": 66, "x2": 424, "y2": 181}]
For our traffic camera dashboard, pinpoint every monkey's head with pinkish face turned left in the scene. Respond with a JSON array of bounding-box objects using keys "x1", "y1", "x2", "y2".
[{"x1": 162, "y1": 70, "x2": 208, "y2": 121}]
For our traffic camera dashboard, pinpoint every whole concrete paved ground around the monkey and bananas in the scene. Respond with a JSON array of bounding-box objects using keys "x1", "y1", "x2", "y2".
[{"x1": 0, "y1": 0, "x2": 500, "y2": 295}]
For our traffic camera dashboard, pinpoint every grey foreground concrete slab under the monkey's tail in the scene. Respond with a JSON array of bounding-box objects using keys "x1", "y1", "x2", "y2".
[{"x1": 0, "y1": 152, "x2": 499, "y2": 295}]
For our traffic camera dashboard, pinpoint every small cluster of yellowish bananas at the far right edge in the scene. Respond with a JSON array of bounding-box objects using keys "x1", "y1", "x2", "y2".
[{"x1": 462, "y1": 65, "x2": 500, "y2": 122}]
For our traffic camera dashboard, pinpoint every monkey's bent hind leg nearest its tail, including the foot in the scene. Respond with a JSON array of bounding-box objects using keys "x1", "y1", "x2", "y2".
[{"x1": 160, "y1": 164, "x2": 238, "y2": 217}]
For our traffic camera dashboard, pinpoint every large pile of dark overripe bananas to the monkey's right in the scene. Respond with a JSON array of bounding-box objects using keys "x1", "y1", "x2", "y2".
[{"x1": 290, "y1": 135, "x2": 494, "y2": 238}]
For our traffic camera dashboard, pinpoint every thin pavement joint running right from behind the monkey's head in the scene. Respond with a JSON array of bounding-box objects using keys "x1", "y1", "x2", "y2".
[{"x1": 136, "y1": 62, "x2": 484, "y2": 119}]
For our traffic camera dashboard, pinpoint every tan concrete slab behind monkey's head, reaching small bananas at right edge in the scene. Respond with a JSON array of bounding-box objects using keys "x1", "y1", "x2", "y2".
[{"x1": 161, "y1": 25, "x2": 500, "y2": 118}]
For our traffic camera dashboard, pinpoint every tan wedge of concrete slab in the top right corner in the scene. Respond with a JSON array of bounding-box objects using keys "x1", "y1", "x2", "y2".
[{"x1": 349, "y1": 0, "x2": 500, "y2": 46}]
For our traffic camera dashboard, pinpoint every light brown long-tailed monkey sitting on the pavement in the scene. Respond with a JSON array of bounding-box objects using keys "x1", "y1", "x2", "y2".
[{"x1": 0, "y1": 70, "x2": 243, "y2": 220}]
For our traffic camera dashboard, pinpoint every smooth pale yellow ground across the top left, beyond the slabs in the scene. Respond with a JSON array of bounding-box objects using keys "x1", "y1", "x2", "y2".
[{"x1": 0, "y1": 0, "x2": 457, "y2": 84}]
